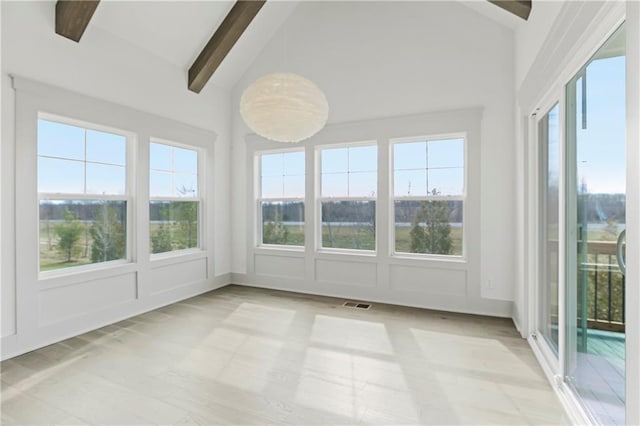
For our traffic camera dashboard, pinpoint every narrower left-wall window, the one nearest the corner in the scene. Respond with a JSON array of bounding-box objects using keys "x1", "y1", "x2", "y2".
[{"x1": 149, "y1": 142, "x2": 200, "y2": 253}]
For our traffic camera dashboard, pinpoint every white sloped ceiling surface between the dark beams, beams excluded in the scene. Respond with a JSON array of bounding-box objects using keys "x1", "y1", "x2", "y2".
[{"x1": 89, "y1": 0, "x2": 524, "y2": 89}]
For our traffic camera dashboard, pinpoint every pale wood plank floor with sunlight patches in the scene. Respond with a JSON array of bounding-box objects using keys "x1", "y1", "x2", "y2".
[{"x1": 1, "y1": 286, "x2": 568, "y2": 425}]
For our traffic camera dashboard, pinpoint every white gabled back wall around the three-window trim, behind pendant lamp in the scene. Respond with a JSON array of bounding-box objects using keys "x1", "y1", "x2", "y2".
[{"x1": 231, "y1": 2, "x2": 516, "y2": 314}]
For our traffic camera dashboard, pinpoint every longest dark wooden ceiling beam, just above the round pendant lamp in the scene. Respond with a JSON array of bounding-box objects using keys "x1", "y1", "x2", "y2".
[{"x1": 189, "y1": 0, "x2": 266, "y2": 93}]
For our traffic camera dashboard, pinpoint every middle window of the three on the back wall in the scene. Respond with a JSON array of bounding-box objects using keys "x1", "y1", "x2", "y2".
[{"x1": 320, "y1": 145, "x2": 378, "y2": 250}]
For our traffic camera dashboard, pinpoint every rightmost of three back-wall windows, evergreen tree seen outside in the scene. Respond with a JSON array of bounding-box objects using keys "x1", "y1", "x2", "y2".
[{"x1": 392, "y1": 137, "x2": 465, "y2": 256}]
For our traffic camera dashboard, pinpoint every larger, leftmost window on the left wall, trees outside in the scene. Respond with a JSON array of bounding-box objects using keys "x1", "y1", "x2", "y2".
[{"x1": 37, "y1": 118, "x2": 128, "y2": 272}]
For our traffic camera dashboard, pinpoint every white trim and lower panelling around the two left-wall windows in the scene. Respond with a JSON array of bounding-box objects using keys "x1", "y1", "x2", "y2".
[{"x1": 9, "y1": 75, "x2": 218, "y2": 358}]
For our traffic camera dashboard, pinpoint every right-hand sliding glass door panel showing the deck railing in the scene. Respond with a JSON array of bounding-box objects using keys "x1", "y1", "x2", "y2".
[{"x1": 564, "y1": 26, "x2": 626, "y2": 425}]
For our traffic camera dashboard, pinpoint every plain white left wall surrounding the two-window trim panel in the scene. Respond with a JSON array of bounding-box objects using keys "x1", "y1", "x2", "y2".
[{"x1": 1, "y1": 1, "x2": 231, "y2": 358}]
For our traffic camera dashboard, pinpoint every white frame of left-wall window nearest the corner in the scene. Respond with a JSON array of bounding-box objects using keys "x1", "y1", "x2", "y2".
[{"x1": 146, "y1": 136, "x2": 206, "y2": 261}]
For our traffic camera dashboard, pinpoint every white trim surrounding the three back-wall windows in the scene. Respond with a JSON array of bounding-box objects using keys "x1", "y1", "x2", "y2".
[{"x1": 243, "y1": 107, "x2": 480, "y2": 284}]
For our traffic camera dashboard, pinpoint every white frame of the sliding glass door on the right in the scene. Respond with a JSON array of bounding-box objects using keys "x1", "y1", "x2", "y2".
[{"x1": 521, "y1": 2, "x2": 640, "y2": 424}]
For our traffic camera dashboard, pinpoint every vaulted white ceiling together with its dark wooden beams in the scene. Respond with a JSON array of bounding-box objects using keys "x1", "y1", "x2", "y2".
[{"x1": 56, "y1": 0, "x2": 531, "y2": 92}]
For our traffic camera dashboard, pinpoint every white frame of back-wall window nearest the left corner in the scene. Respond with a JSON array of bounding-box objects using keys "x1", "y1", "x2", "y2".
[{"x1": 253, "y1": 146, "x2": 308, "y2": 252}]
